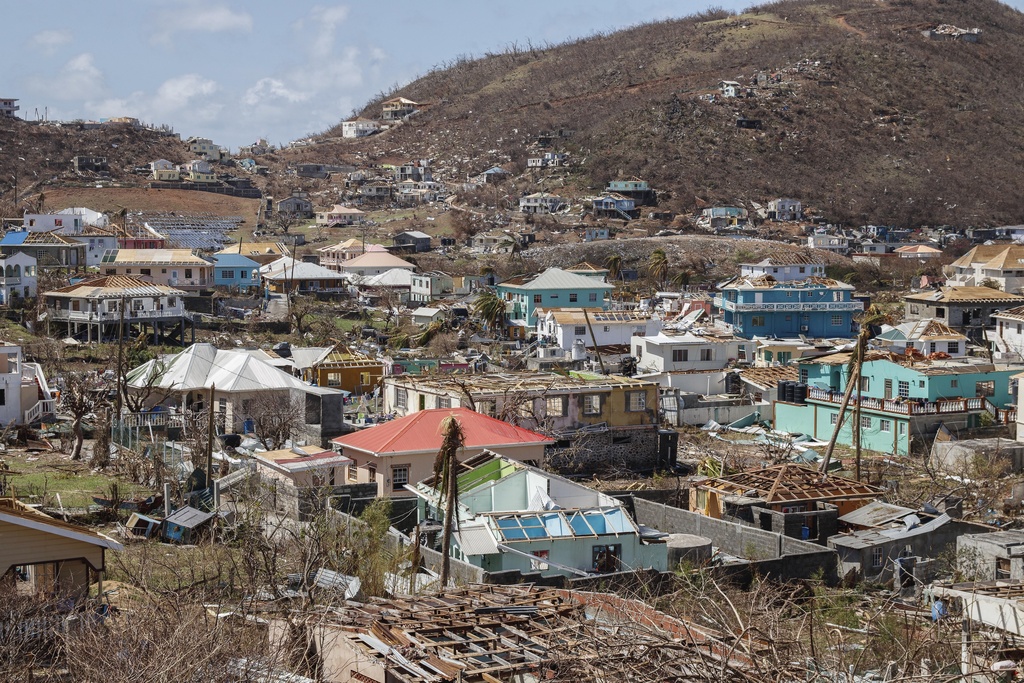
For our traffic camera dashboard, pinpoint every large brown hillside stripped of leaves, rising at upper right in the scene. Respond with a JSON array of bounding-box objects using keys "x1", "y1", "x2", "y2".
[{"x1": 307, "y1": 0, "x2": 1024, "y2": 225}]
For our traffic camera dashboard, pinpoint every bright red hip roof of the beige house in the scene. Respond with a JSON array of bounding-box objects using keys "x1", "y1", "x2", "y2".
[{"x1": 332, "y1": 408, "x2": 554, "y2": 456}]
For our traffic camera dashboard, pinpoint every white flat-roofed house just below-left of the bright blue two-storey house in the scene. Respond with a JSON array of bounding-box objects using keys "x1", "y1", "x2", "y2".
[{"x1": 632, "y1": 333, "x2": 749, "y2": 374}]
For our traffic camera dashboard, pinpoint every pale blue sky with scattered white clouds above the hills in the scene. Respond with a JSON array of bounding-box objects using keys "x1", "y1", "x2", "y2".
[{"x1": 0, "y1": 0, "x2": 1024, "y2": 148}]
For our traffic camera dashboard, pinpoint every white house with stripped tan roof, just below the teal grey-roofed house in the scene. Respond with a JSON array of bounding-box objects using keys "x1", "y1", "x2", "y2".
[{"x1": 537, "y1": 308, "x2": 662, "y2": 351}]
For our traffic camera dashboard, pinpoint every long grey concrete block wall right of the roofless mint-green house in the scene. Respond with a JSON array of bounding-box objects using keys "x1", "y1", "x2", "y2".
[{"x1": 633, "y1": 499, "x2": 837, "y2": 581}]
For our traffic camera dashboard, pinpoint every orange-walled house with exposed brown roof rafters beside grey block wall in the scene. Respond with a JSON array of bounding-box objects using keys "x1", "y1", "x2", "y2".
[{"x1": 690, "y1": 463, "x2": 882, "y2": 545}]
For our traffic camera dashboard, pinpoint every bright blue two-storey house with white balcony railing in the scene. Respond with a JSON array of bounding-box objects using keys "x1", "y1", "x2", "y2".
[{"x1": 715, "y1": 265, "x2": 864, "y2": 339}]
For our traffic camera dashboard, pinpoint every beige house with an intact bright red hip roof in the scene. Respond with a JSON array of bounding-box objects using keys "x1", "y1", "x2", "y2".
[{"x1": 332, "y1": 408, "x2": 554, "y2": 498}]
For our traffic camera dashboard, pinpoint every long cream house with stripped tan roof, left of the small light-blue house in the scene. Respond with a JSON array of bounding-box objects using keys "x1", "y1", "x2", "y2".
[{"x1": 99, "y1": 249, "x2": 213, "y2": 291}]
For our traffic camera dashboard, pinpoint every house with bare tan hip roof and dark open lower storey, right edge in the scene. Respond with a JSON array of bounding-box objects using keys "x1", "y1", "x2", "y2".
[{"x1": 903, "y1": 286, "x2": 1024, "y2": 341}]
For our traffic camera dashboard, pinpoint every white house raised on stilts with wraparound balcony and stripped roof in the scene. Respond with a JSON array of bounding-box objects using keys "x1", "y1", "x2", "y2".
[{"x1": 43, "y1": 275, "x2": 196, "y2": 346}]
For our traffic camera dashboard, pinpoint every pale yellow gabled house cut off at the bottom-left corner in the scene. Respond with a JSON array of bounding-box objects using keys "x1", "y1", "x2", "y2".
[{"x1": 0, "y1": 498, "x2": 123, "y2": 598}]
